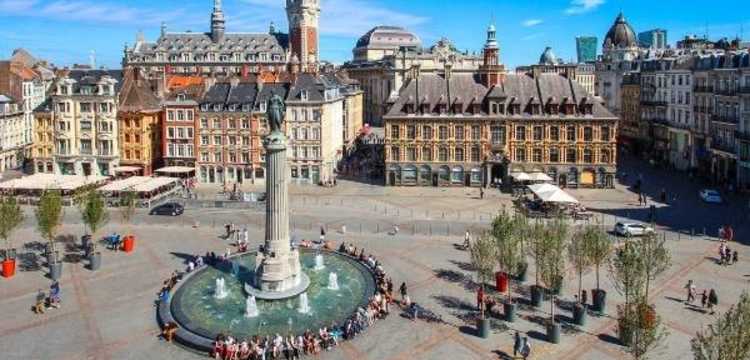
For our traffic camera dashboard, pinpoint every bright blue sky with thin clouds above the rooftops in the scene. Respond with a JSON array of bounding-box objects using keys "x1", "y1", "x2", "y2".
[{"x1": 0, "y1": 0, "x2": 750, "y2": 68}]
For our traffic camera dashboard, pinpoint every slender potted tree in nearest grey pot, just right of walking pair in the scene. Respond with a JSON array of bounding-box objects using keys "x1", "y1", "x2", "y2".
[{"x1": 537, "y1": 218, "x2": 569, "y2": 344}]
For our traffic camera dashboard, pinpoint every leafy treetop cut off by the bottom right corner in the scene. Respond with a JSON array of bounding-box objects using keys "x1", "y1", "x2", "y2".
[{"x1": 690, "y1": 292, "x2": 750, "y2": 360}]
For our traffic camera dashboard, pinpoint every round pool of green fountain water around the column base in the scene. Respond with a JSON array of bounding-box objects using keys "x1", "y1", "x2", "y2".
[{"x1": 158, "y1": 250, "x2": 375, "y2": 351}]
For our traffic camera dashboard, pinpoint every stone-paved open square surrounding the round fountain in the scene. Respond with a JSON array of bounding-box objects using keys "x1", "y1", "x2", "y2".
[{"x1": 0, "y1": 161, "x2": 750, "y2": 360}]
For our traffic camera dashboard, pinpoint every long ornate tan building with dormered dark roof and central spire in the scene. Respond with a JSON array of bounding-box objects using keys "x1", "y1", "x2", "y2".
[{"x1": 384, "y1": 26, "x2": 618, "y2": 187}]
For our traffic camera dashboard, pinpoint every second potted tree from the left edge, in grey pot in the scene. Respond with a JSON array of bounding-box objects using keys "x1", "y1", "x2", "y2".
[{"x1": 35, "y1": 190, "x2": 63, "y2": 280}]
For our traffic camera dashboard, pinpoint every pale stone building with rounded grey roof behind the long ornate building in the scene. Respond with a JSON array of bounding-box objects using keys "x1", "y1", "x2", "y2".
[{"x1": 344, "y1": 26, "x2": 482, "y2": 126}]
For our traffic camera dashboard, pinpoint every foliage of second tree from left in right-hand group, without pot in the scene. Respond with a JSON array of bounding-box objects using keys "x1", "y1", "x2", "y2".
[{"x1": 492, "y1": 209, "x2": 526, "y2": 302}]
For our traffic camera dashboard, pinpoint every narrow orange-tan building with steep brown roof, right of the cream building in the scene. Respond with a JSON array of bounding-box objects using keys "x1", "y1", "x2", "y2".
[{"x1": 117, "y1": 69, "x2": 164, "y2": 176}]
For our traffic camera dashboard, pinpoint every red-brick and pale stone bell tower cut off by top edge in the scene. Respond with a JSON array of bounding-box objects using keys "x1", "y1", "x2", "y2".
[{"x1": 286, "y1": 0, "x2": 320, "y2": 71}]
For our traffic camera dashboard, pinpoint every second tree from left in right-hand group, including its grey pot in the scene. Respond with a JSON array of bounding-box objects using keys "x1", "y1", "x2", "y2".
[{"x1": 492, "y1": 211, "x2": 526, "y2": 322}]
